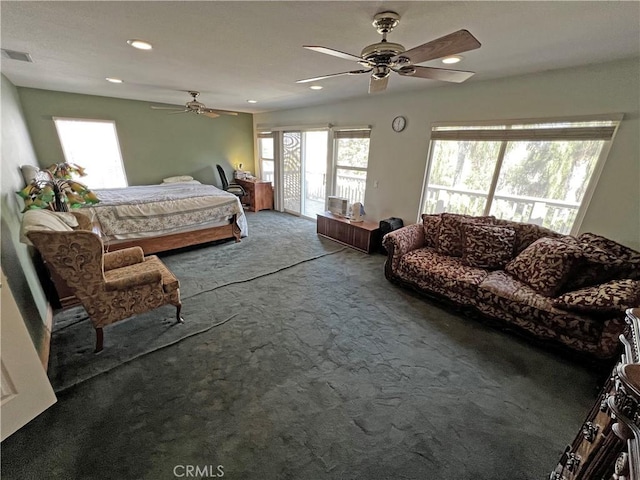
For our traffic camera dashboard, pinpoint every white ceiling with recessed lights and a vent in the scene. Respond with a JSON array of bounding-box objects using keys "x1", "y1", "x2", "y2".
[{"x1": 0, "y1": 0, "x2": 640, "y2": 113}]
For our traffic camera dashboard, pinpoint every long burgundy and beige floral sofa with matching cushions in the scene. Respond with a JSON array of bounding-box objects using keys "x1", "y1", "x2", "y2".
[{"x1": 383, "y1": 213, "x2": 640, "y2": 359}]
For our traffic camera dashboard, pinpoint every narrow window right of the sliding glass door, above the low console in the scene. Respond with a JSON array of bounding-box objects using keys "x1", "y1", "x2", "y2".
[{"x1": 333, "y1": 129, "x2": 371, "y2": 204}]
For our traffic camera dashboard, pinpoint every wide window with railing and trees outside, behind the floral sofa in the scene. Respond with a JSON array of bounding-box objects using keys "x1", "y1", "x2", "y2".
[{"x1": 421, "y1": 118, "x2": 620, "y2": 233}]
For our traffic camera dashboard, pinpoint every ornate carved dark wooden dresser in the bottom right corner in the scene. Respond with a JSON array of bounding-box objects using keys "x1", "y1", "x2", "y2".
[{"x1": 549, "y1": 308, "x2": 640, "y2": 480}]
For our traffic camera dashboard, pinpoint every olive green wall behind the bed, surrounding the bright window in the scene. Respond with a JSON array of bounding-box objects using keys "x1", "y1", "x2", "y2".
[{"x1": 18, "y1": 87, "x2": 254, "y2": 186}]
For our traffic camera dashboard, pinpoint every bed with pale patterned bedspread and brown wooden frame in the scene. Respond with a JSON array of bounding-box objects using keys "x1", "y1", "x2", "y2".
[{"x1": 80, "y1": 180, "x2": 248, "y2": 255}]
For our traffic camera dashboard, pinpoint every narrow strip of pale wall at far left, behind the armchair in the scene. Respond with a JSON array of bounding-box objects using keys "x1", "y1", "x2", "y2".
[{"x1": 0, "y1": 75, "x2": 48, "y2": 349}]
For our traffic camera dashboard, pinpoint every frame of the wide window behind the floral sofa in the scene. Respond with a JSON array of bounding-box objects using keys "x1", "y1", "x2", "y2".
[{"x1": 417, "y1": 114, "x2": 624, "y2": 235}]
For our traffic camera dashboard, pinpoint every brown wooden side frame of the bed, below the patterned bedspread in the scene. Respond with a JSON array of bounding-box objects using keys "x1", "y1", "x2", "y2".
[{"x1": 105, "y1": 215, "x2": 240, "y2": 255}]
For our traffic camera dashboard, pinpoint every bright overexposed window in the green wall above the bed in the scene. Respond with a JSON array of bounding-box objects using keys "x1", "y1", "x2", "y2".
[{"x1": 53, "y1": 117, "x2": 127, "y2": 189}]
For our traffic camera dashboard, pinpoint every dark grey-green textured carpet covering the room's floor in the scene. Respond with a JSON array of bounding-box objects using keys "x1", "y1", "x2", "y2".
[{"x1": 2, "y1": 212, "x2": 597, "y2": 480}]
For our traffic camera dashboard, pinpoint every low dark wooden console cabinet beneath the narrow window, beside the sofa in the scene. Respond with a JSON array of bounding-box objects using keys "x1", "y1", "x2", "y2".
[{"x1": 317, "y1": 212, "x2": 380, "y2": 253}]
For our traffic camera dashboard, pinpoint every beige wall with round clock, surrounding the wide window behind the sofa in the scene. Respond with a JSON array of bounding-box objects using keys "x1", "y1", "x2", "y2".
[{"x1": 254, "y1": 59, "x2": 640, "y2": 249}]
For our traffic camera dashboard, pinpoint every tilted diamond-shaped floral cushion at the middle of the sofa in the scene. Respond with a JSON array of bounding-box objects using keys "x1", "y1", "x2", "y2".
[{"x1": 505, "y1": 237, "x2": 580, "y2": 297}]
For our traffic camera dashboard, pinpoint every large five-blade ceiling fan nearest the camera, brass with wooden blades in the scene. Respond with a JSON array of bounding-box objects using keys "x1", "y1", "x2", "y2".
[{"x1": 296, "y1": 12, "x2": 480, "y2": 93}]
